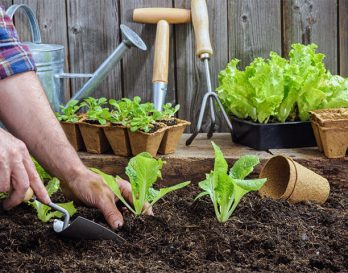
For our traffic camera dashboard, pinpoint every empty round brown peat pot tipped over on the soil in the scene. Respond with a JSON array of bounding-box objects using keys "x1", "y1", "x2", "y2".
[{"x1": 259, "y1": 155, "x2": 330, "y2": 204}]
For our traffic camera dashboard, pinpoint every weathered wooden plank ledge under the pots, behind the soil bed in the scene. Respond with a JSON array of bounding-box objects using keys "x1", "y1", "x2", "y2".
[{"x1": 80, "y1": 133, "x2": 348, "y2": 187}]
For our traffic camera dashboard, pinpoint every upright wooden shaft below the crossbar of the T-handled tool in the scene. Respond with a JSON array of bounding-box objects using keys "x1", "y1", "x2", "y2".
[{"x1": 152, "y1": 20, "x2": 169, "y2": 83}]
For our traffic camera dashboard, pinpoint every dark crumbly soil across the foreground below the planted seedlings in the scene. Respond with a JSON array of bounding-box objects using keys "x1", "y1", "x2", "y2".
[{"x1": 0, "y1": 183, "x2": 348, "y2": 273}]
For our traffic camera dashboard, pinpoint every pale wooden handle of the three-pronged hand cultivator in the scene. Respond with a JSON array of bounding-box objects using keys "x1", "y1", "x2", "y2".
[{"x1": 191, "y1": 0, "x2": 213, "y2": 56}]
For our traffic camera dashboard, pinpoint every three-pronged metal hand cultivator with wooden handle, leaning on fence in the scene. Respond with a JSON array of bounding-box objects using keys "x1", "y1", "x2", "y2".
[{"x1": 186, "y1": 0, "x2": 232, "y2": 146}]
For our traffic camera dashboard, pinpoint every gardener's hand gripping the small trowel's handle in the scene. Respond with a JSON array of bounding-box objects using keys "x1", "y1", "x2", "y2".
[{"x1": 0, "y1": 129, "x2": 50, "y2": 210}]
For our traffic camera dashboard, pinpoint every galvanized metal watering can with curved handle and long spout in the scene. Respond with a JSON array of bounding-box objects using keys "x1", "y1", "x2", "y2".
[{"x1": 6, "y1": 4, "x2": 147, "y2": 111}]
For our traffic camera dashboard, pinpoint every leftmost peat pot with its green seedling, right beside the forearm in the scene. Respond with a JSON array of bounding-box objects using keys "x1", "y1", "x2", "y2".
[{"x1": 56, "y1": 100, "x2": 85, "y2": 151}]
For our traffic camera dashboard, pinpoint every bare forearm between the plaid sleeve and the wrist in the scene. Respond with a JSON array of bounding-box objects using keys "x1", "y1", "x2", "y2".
[{"x1": 0, "y1": 72, "x2": 85, "y2": 181}]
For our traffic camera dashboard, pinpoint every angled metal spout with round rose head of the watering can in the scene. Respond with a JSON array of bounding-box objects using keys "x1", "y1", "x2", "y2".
[{"x1": 68, "y1": 25, "x2": 147, "y2": 103}]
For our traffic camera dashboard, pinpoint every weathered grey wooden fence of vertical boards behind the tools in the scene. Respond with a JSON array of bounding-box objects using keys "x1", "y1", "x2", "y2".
[{"x1": 0, "y1": 0, "x2": 348, "y2": 130}]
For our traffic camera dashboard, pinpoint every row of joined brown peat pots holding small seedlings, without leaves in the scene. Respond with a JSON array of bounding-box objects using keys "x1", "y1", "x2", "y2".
[{"x1": 60, "y1": 118, "x2": 190, "y2": 156}]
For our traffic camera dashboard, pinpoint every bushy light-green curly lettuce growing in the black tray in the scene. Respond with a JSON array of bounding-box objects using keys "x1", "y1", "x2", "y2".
[{"x1": 216, "y1": 44, "x2": 348, "y2": 123}]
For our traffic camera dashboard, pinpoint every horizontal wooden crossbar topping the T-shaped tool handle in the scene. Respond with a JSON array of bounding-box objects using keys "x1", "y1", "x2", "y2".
[{"x1": 133, "y1": 8, "x2": 191, "y2": 24}]
